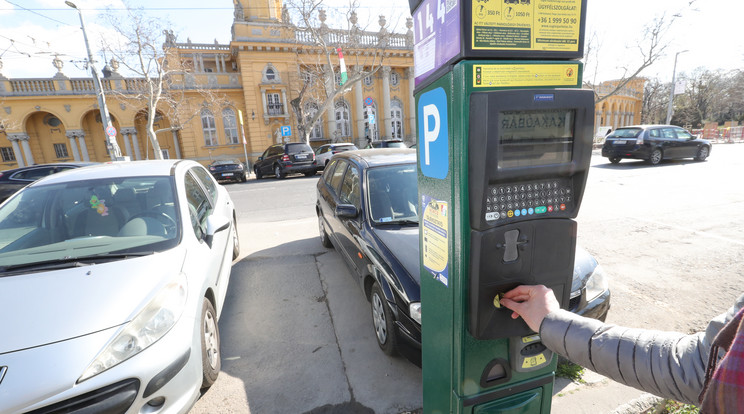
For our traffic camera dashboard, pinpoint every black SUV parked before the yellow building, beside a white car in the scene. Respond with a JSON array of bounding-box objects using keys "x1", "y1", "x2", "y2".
[{"x1": 253, "y1": 142, "x2": 318, "y2": 179}]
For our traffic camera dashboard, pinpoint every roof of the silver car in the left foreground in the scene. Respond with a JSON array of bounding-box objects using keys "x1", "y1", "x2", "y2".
[{"x1": 26, "y1": 160, "x2": 192, "y2": 187}]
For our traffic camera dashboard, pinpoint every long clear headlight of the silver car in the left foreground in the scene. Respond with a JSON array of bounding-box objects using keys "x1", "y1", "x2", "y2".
[{"x1": 77, "y1": 273, "x2": 187, "y2": 383}]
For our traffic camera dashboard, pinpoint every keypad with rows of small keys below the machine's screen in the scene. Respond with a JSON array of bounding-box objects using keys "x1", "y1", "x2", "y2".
[{"x1": 485, "y1": 178, "x2": 574, "y2": 224}]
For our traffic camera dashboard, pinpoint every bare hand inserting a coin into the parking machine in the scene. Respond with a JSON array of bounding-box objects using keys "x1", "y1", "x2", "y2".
[{"x1": 500, "y1": 285, "x2": 561, "y2": 332}]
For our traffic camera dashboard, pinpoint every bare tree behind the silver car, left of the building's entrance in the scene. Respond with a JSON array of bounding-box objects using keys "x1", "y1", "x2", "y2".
[{"x1": 104, "y1": 7, "x2": 225, "y2": 159}]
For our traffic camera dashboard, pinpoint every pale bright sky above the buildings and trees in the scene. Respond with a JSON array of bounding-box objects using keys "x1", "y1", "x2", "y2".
[{"x1": 0, "y1": 0, "x2": 744, "y2": 82}]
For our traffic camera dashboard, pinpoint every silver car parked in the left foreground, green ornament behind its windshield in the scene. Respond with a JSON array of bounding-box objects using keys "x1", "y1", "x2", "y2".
[{"x1": 0, "y1": 160, "x2": 239, "y2": 413}]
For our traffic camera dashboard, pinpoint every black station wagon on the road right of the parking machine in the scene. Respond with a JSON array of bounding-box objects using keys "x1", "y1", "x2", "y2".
[{"x1": 602, "y1": 125, "x2": 711, "y2": 165}]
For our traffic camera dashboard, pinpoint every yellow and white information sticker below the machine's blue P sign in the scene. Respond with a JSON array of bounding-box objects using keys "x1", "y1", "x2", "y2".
[{"x1": 421, "y1": 195, "x2": 449, "y2": 286}]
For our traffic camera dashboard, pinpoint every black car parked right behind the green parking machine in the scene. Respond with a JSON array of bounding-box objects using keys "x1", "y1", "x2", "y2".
[{"x1": 316, "y1": 149, "x2": 610, "y2": 365}]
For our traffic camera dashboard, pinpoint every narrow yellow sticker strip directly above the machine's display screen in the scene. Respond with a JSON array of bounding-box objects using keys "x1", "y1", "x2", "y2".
[{"x1": 473, "y1": 63, "x2": 579, "y2": 88}]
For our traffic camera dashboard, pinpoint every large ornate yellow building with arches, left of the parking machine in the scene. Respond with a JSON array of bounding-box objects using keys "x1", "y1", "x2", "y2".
[{"x1": 0, "y1": 0, "x2": 415, "y2": 170}]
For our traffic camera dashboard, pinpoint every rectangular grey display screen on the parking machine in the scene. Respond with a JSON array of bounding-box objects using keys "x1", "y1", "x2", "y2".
[{"x1": 498, "y1": 109, "x2": 575, "y2": 169}]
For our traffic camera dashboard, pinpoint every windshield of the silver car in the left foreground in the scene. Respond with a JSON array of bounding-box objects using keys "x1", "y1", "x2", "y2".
[{"x1": 0, "y1": 177, "x2": 181, "y2": 273}]
